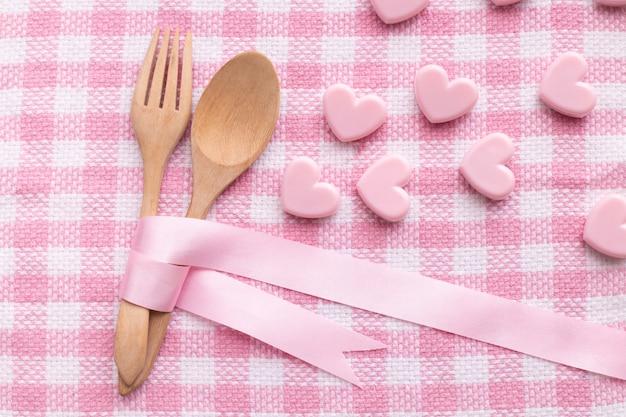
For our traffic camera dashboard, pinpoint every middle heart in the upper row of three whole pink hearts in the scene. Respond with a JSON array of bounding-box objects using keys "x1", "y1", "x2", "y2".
[{"x1": 414, "y1": 65, "x2": 478, "y2": 123}]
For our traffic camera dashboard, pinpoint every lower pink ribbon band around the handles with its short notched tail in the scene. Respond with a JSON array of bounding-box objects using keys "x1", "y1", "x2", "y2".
[{"x1": 120, "y1": 245, "x2": 385, "y2": 385}]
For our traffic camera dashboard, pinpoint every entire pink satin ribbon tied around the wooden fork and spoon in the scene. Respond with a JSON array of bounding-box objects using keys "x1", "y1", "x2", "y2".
[{"x1": 121, "y1": 217, "x2": 626, "y2": 384}]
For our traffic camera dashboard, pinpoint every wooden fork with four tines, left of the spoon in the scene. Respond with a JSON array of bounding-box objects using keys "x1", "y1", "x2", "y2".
[{"x1": 114, "y1": 28, "x2": 192, "y2": 395}]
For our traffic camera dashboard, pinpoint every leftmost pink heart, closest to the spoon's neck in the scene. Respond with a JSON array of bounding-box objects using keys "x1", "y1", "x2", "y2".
[{"x1": 280, "y1": 157, "x2": 340, "y2": 219}]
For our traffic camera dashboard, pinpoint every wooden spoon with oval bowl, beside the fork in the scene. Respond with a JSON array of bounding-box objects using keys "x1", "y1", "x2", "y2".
[{"x1": 119, "y1": 51, "x2": 280, "y2": 395}]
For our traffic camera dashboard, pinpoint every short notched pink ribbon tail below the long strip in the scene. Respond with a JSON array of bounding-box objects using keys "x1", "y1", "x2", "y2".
[{"x1": 176, "y1": 268, "x2": 386, "y2": 386}]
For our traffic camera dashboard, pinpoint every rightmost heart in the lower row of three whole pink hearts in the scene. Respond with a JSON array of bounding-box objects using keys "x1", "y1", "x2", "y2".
[{"x1": 460, "y1": 133, "x2": 515, "y2": 200}]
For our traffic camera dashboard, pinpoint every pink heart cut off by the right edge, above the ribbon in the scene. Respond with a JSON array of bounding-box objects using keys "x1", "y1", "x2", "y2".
[{"x1": 583, "y1": 194, "x2": 626, "y2": 258}]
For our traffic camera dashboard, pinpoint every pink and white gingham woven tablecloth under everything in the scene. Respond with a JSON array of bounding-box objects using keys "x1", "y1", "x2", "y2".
[{"x1": 0, "y1": 0, "x2": 626, "y2": 417}]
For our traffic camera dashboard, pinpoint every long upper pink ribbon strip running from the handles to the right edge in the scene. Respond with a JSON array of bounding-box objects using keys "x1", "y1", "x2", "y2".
[{"x1": 133, "y1": 216, "x2": 626, "y2": 380}]
